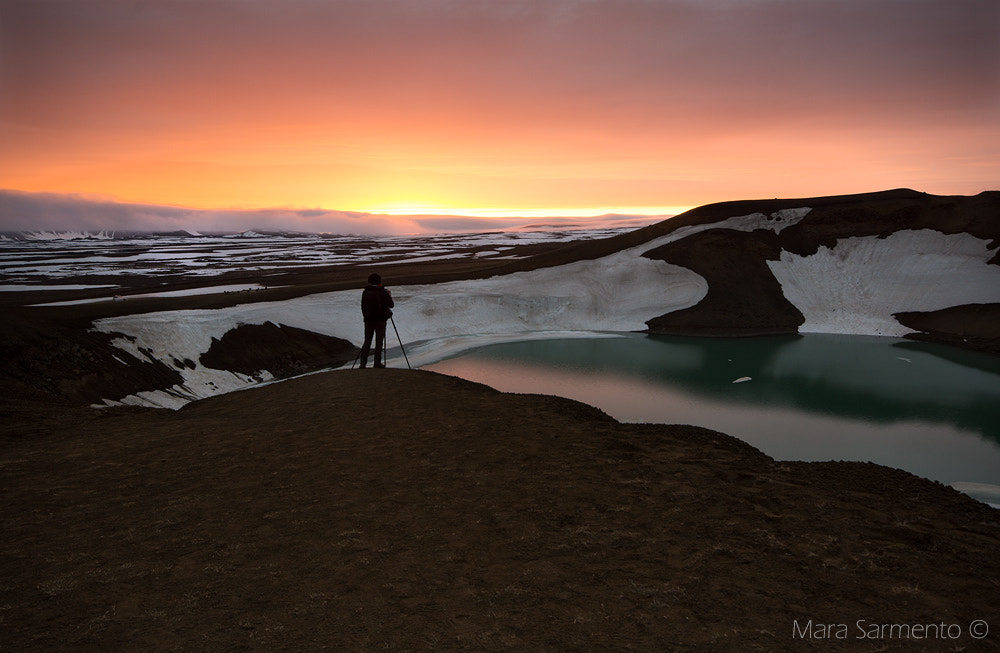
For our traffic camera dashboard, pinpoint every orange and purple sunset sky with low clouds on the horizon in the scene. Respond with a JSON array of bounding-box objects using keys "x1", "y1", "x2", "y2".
[{"x1": 0, "y1": 0, "x2": 1000, "y2": 231}]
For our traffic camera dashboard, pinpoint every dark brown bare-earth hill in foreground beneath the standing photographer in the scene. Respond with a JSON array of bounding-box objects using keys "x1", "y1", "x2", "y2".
[{"x1": 0, "y1": 370, "x2": 1000, "y2": 651}]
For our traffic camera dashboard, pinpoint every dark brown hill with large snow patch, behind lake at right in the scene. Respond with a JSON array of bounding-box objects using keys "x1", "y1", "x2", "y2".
[{"x1": 647, "y1": 190, "x2": 1000, "y2": 338}]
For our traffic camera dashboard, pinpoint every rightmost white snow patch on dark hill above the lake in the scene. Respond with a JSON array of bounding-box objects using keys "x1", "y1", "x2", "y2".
[{"x1": 768, "y1": 229, "x2": 1000, "y2": 337}]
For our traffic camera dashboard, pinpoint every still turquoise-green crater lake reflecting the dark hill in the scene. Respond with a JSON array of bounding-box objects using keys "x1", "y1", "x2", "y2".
[{"x1": 425, "y1": 334, "x2": 1000, "y2": 492}]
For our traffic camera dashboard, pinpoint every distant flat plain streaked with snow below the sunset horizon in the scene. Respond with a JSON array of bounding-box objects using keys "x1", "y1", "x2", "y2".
[{"x1": 0, "y1": 227, "x2": 631, "y2": 295}]
